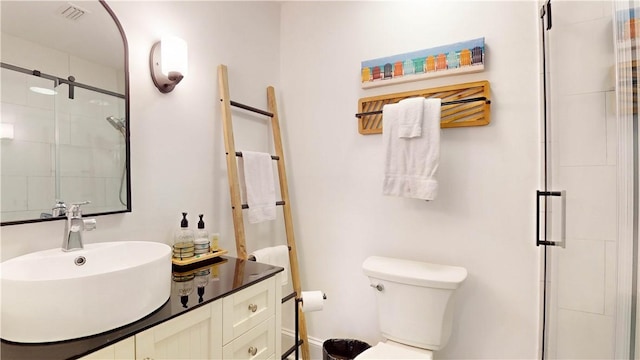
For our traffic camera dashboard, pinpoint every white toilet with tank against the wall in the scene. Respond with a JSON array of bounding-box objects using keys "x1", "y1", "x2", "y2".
[{"x1": 356, "y1": 256, "x2": 467, "y2": 360}]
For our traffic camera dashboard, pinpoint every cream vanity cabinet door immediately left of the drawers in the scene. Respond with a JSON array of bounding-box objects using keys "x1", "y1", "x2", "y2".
[{"x1": 136, "y1": 301, "x2": 222, "y2": 360}]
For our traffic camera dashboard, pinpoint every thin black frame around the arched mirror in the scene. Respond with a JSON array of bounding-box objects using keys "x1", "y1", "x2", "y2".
[{"x1": 0, "y1": 0, "x2": 131, "y2": 226}]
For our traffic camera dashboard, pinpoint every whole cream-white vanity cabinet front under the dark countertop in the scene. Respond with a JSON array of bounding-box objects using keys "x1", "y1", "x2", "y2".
[{"x1": 81, "y1": 273, "x2": 282, "y2": 360}]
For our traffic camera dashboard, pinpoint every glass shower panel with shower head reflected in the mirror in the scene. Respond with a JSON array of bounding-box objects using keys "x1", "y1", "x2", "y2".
[{"x1": 56, "y1": 83, "x2": 128, "y2": 213}]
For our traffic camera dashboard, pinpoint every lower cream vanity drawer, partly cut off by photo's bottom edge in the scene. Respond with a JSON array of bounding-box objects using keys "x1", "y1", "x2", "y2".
[{"x1": 222, "y1": 316, "x2": 276, "y2": 360}]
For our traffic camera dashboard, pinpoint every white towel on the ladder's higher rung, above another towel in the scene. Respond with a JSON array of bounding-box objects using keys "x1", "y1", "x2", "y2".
[{"x1": 242, "y1": 151, "x2": 276, "y2": 224}]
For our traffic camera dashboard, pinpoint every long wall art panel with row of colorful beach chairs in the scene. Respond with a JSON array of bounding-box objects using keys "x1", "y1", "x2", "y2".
[{"x1": 361, "y1": 38, "x2": 485, "y2": 89}]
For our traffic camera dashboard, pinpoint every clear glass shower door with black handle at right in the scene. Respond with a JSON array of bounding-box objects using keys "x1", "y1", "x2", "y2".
[{"x1": 536, "y1": 0, "x2": 619, "y2": 359}]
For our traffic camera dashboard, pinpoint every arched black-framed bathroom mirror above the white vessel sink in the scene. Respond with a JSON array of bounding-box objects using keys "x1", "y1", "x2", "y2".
[{"x1": 0, "y1": 0, "x2": 131, "y2": 225}]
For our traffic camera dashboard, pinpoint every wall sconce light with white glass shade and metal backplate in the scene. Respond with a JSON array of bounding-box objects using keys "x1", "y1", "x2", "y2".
[{"x1": 149, "y1": 36, "x2": 187, "y2": 93}]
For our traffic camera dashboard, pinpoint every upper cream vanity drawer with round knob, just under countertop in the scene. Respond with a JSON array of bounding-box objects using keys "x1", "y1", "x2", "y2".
[{"x1": 222, "y1": 277, "x2": 276, "y2": 344}]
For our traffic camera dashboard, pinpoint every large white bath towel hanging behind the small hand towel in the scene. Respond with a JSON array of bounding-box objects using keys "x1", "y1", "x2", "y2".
[{"x1": 382, "y1": 99, "x2": 441, "y2": 200}]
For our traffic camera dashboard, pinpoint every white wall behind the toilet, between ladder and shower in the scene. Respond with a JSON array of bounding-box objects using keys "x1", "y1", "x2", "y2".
[{"x1": 281, "y1": 1, "x2": 539, "y2": 359}]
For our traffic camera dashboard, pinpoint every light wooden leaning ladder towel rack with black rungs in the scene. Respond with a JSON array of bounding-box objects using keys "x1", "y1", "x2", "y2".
[{"x1": 218, "y1": 65, "x2": 311, "y2": 360}]
